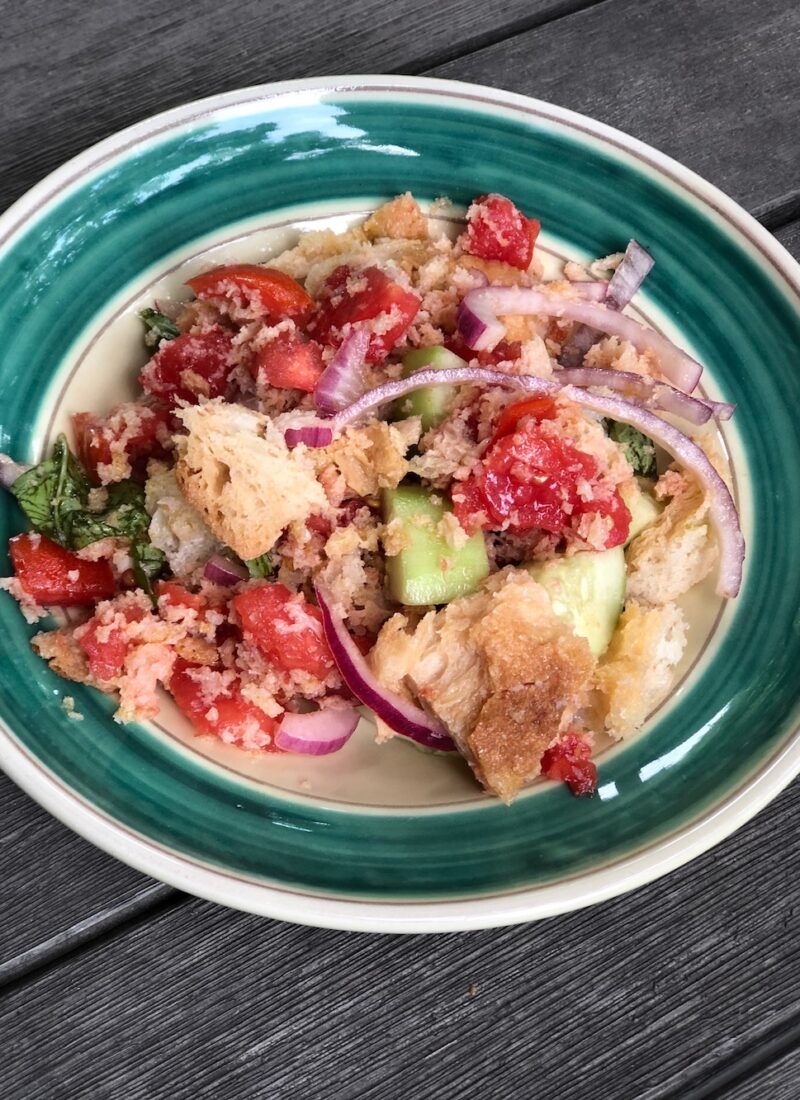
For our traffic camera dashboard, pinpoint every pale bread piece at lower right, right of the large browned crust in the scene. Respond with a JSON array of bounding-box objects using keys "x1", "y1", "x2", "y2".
[{"x1": 594, "y1": 601, "x2": 687, "y2": 740}]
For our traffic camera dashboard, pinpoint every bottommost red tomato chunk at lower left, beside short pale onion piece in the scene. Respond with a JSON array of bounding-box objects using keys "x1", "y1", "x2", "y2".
[{"x1": 169, "y1": 658, "x2": 281, "y2": 752}]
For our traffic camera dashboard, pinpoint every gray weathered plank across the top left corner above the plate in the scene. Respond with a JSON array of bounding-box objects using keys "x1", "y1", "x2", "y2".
[{"x1": 0, "y1": 0, "x2": 598, "y2": 209}]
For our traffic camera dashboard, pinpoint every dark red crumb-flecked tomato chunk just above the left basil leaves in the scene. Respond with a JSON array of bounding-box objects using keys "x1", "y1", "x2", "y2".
[{"x1": 73, "y1": 402, "x2": 171, "y2": 482}]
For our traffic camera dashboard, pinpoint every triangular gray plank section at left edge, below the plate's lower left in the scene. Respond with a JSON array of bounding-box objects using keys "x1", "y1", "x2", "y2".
[{"x1": 0, "y1": 774, "x2": 172, "y2": 972}]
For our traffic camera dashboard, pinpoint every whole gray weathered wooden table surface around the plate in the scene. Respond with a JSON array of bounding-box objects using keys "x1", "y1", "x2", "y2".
[{"x1": 0, "y1": 0, "x2": 800, "y2": 1100}]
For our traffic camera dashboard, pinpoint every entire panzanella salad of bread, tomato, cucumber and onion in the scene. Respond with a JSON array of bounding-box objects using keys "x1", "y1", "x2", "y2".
[{"x1": 2, "y1": 195, "x2": 744, "y2": 802}]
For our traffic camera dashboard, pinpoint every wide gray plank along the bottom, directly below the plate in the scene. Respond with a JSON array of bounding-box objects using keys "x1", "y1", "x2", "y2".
[{"x1": 0, "y1": 783, "x2": 800, "y2": 1100}]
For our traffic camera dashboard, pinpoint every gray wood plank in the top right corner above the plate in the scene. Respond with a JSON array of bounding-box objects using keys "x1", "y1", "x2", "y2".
[{"x1": 435, "y1": 0, "x2": 800, "y2": 218}]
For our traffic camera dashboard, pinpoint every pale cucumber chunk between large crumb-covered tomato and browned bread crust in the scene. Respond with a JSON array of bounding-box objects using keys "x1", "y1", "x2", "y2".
[{"x1": 525, "y1": 547, "x2": 625, "y2": 657}]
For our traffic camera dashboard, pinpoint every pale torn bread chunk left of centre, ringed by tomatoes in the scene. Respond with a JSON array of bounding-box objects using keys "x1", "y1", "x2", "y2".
[{"x1": 175, "y1": 399, "x2": 328, "y2": 560}]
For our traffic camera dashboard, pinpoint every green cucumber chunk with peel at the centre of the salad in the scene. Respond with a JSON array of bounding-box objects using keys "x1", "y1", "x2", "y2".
[{"x1": 382, "y1": 485, "x2": 489, "y2": 606}]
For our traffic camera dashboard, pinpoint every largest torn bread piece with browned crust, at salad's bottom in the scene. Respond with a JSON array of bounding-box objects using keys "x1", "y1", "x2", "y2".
[{"x1": 371, "y1": 569, "x2": 595, "y2": 802}]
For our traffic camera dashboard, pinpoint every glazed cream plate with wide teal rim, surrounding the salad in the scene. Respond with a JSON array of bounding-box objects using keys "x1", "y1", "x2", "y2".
[{"x1": 0, "y1": 76, "x2": 800, "y2": 932}]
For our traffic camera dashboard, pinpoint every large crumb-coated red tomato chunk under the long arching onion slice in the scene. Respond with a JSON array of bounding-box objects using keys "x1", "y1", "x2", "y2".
[{"x1": 453, "y1": 419, "x2": 631, "y2": 549}]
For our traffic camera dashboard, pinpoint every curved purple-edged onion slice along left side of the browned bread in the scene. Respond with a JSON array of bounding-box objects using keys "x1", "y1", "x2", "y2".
[{"x1": 315, "y1": 585, "x2": 457, "y2": 752}]
